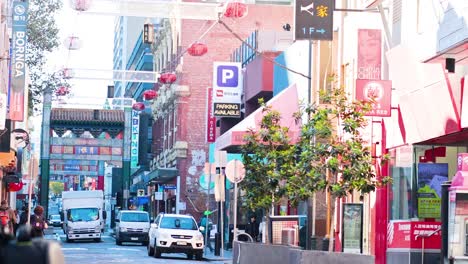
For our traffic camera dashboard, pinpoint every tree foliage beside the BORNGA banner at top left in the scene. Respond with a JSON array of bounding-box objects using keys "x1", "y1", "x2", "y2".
[{"x1": 26, "y1": 0, "x2": 70, "y2": 114}]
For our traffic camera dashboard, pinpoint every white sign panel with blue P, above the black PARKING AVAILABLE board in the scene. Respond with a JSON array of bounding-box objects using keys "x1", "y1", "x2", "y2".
[{"x1": 213, "y1": 62, "x2": 243, "y2": 106}]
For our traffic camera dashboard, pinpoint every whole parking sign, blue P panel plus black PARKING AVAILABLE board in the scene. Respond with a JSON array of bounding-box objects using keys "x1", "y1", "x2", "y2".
[{"x1": 213, "y1": 62, "x2": 243, "y2": 118}]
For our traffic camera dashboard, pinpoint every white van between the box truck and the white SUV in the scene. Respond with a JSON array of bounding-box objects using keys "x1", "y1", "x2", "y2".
[{"x1": 115, "y1": 210, "x2": 150, "y2": 246}]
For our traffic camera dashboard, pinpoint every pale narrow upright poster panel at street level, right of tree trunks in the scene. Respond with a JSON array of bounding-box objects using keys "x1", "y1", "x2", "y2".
[{"x1": 343, "y1": 204, "x2": 363, "y2": 254}]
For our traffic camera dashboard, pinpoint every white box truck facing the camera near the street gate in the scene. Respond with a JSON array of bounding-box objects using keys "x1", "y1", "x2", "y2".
[{"x1": 62, "y1": 191, "x2": 106, "y2": 242}]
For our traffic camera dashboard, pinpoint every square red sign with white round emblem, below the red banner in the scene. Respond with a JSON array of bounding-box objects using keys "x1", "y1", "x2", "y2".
[{"x1": 356, "y1": 79, "x2": 392, "y2": 117}]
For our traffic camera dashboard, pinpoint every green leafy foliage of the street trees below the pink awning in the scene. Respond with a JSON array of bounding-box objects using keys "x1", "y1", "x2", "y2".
[{"x1": 241, "y1": 88, "x2": 389, "y2": 212}]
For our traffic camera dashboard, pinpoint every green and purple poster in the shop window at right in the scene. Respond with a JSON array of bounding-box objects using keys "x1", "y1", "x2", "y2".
[{"x1": 418, "y1": 163, "x2": 448, "y2": 218}]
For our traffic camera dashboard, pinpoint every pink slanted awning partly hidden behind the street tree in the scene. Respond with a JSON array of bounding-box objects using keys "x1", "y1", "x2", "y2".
[{"x1": 215, "y1": 84, "x2": 301, "y2": 152}]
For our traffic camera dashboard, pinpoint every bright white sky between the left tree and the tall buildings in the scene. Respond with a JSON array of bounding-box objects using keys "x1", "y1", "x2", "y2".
[{"x1": 48, "y1": 0, "x2": 115, "y2": 108}]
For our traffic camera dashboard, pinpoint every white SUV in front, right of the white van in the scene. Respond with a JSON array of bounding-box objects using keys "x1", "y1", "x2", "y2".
[{"x1": 148, "y1": 213, "x2": 204, "y2": 260}]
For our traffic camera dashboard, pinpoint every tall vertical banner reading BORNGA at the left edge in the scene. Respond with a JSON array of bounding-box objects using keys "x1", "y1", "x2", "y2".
[{"x1": 10, "y1": 1, "x2": 28, "y2": 121}]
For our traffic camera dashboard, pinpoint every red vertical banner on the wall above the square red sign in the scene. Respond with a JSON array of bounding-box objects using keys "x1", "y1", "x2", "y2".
[{"x1": 357, "y1": 29, "x2": 382, "y2": 80}]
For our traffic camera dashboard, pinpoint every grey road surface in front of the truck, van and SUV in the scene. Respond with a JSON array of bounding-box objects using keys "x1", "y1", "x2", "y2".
[{"x1": 46, "y1": 227, "x2": 231, "y2": 264}]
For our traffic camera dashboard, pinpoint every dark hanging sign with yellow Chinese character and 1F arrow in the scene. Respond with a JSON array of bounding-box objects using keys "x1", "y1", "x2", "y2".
[{"x1": 294, "y1": 0, "x2": 335, "y2": 40}]
